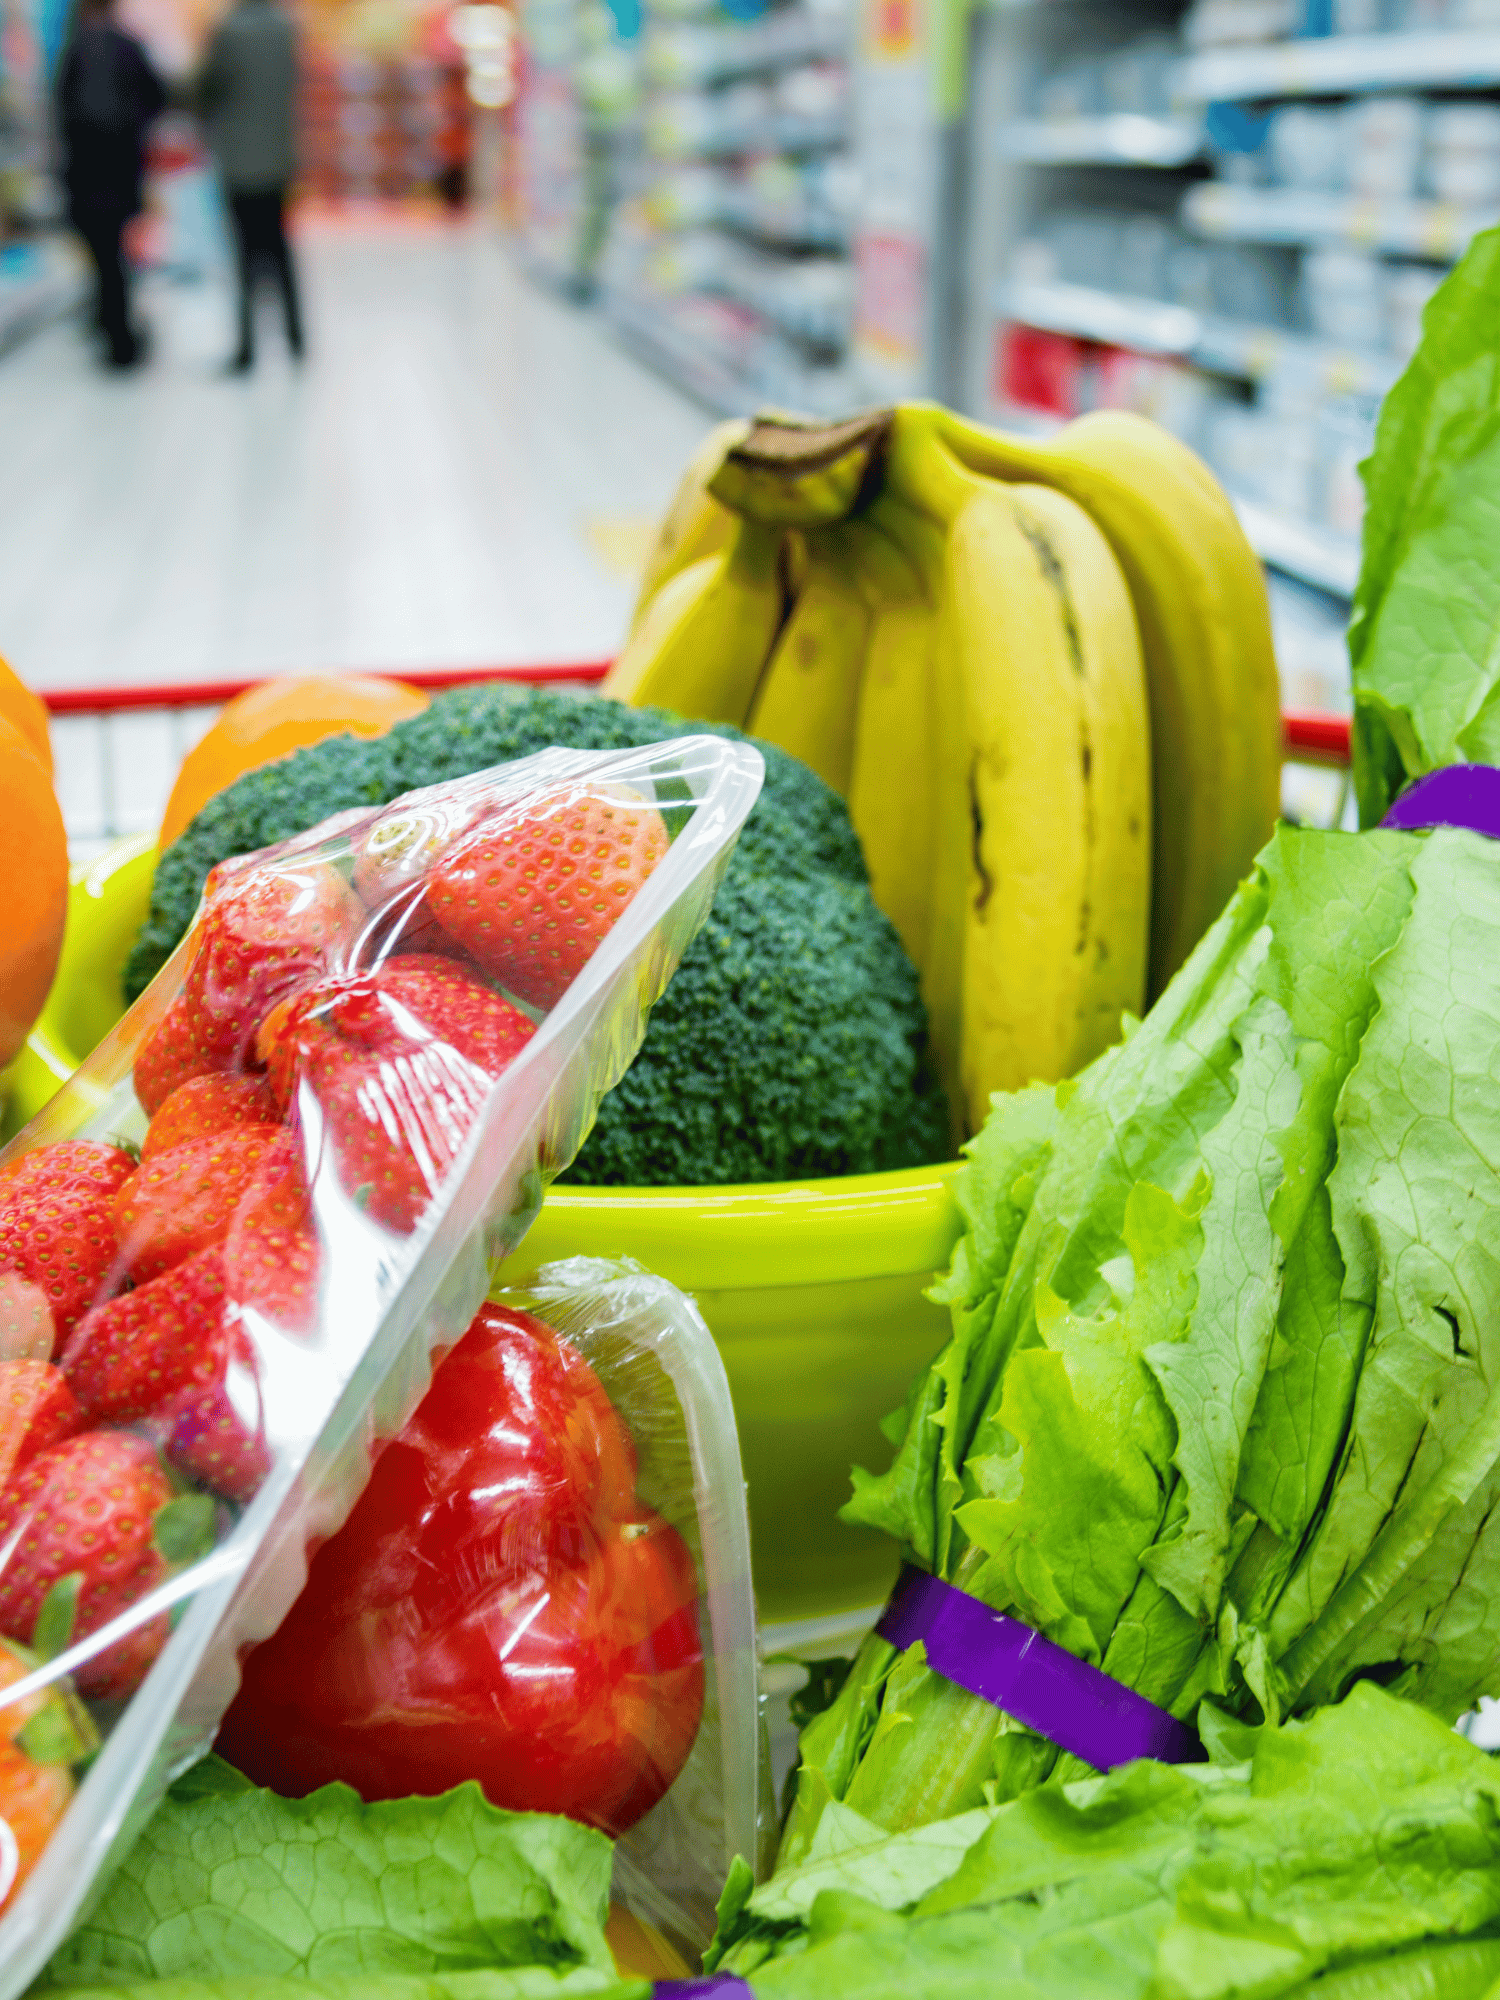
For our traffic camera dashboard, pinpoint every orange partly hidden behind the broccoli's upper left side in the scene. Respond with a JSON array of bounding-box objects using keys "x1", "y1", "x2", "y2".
[{"x1": 158, "y1": 674, "x2": 428, "y2": 848}]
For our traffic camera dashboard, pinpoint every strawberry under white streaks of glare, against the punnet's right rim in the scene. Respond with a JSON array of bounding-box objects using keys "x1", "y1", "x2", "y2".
[{"x1": 260, "y1": 956, "x2": 534, "y2": 1230}]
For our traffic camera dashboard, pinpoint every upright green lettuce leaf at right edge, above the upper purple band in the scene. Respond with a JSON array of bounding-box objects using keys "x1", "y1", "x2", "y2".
[{"x1": 1348, "y1": 230, "x2": 1500, "y2": 826}]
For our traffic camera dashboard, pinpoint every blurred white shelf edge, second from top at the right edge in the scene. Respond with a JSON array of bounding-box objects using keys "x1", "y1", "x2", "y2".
[{"x1": 1182, "y1": 180, "x2": 1496, "y2": 262}]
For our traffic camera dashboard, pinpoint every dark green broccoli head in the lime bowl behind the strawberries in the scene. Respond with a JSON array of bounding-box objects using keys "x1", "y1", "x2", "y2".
[{"x1": 124, "y1": 682, "x2": 948, "y2": 1186}]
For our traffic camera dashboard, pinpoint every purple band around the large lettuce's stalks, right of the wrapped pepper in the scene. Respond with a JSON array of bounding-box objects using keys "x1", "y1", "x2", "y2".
[{"x1": 876, "y1": 1564, "x2": 1204, "y2": 1770}]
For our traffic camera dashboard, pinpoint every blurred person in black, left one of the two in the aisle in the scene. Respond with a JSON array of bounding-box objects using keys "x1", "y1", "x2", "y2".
[{"x1": 58, "y1": 0, "x2": 166, "y2": 368}]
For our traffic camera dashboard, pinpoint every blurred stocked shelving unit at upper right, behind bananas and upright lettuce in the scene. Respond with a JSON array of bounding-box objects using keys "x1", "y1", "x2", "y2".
[{"x1": 966, "y1": 0, "x2": 1500, "y2": 652}]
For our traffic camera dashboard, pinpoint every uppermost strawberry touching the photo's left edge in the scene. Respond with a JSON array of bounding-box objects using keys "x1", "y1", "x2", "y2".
[{"x1": 0, "y1": 1140, "x2": 136, "y2": 1340}]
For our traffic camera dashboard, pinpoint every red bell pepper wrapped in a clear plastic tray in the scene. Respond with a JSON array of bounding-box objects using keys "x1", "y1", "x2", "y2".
[{"x1": 218, "y1": 1258, "x2": 774, "y2": 1958}]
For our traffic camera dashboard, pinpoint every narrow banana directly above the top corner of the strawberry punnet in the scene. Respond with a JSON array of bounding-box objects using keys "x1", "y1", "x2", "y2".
[{"x1": 746, "y1": 522, "x2": 870, "y2": 792}]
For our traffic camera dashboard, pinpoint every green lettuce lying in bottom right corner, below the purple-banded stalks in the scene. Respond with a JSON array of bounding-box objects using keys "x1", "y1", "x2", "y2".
[{"x1": 736, "y1": 1682, "x2": 1500, "y2": 2000}]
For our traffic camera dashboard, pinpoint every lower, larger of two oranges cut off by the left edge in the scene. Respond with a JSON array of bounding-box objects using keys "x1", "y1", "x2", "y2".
[{"x1": 0, "y1": 716, "x2": 68, "y2": 1070}]
